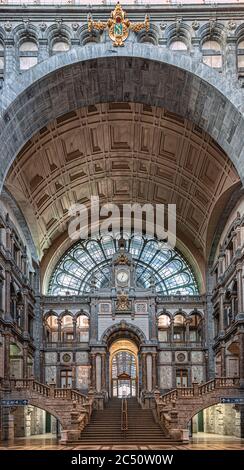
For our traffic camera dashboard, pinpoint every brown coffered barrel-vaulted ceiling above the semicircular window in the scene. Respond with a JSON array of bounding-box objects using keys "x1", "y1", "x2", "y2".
[{"x1": 6, "y1": 103, "x2": 239, "y2": 262}]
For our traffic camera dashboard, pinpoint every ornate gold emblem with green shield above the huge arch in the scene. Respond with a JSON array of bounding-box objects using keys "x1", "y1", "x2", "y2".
[{"x1": 88, "y1": 2, "x2": 150, "y2": 47}]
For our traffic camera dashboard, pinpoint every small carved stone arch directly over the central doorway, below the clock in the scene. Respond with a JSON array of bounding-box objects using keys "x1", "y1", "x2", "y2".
[{"x1": 101, "y1": 320, "x2": 146, "y2": 346}]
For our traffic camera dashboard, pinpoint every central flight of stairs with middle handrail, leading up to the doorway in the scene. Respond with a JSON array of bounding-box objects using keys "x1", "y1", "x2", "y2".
[{"x1": 79, "y1": 398, "x2": 172, "y2": 446}]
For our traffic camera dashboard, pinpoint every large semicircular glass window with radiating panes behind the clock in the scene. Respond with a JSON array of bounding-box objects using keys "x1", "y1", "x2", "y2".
[{"x1": 48, "y1": 235, "x2": 199, "y2": 295}]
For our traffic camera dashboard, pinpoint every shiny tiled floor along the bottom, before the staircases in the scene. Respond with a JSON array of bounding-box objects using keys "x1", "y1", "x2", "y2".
[{"x1": 0, "y1": 433, "x2": 244, "y2": 450}]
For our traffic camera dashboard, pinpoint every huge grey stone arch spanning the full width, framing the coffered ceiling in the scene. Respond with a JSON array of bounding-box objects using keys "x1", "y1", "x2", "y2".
[{"x1": 0, "y1": 42, "x2": 244, "y2": 193}]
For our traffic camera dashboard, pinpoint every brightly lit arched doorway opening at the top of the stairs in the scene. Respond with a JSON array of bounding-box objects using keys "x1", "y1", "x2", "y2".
[{"x1": 109, "y1": 339, "x2": 139, "y2": 398}]
